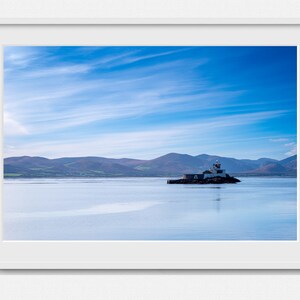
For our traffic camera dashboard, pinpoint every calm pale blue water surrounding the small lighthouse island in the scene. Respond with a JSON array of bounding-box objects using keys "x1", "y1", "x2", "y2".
[{"x1": 3, "y1": 178, "x2": 297, "y2": 240}]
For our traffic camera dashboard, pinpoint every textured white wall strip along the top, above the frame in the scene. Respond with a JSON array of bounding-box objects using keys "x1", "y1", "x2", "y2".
[{"x1": 0, "y1": 0, "x2": 300, "y2": 22}]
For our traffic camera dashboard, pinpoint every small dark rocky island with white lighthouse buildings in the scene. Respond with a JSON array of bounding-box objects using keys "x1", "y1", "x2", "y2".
[{"x1": 167, "y1": 160, "x2": 240, "y2": 184}]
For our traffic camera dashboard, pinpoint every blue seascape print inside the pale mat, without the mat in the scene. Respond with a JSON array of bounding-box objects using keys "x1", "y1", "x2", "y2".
[{"x1": 1, "y1": 46, "x2": 297, "y2": 241}]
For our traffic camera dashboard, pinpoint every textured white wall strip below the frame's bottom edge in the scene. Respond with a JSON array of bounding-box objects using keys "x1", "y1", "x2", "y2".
[{"x1": 0, "y1": 271, "x2": 300, "y2": 300}]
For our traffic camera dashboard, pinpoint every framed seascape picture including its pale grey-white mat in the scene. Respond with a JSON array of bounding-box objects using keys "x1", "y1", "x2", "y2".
[{"x1": 0, "y1": 24, "x2": 300, "y2": 269}]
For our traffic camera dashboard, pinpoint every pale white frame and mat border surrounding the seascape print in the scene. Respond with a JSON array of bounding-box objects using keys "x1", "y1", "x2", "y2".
[{"x1": 0, "y1": 0, "x2": 300, "y2": 269}]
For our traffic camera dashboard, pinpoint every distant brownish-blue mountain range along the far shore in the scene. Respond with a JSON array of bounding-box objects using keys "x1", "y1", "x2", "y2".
[{"x1": 4, "y1": 153, "x2": 297, "y2": 178}]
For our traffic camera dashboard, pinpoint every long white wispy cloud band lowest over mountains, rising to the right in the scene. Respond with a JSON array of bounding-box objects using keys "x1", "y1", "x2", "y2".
[{"x1": 2, "y1": 111, "x2": 284, "y2": 158}]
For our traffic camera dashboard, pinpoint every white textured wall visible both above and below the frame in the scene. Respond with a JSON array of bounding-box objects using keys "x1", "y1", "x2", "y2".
[{"x1": 0, "y1": 0, "x2": 300, "y2": 300}]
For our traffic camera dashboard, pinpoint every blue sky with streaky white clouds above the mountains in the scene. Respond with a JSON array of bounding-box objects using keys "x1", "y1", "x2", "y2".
[{"x1": 4, "y1": 46, "x2": 297, "y2": 159}]
